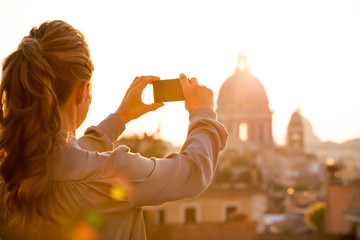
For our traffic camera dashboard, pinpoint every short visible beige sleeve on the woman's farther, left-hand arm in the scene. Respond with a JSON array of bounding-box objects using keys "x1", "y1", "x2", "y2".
[{"x1": 78, "y1": 114, "x2": 125, "y2": 152}]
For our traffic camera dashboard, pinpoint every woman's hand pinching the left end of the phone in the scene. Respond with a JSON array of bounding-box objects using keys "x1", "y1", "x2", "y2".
[{"x1": 115, "y1": 76, "x2": 164, "y2": 124}]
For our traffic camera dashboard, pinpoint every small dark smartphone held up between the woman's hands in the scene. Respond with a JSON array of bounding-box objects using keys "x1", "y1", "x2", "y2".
[{"x1": 153, "y1": 78, "x2": 185, "y2": 103}]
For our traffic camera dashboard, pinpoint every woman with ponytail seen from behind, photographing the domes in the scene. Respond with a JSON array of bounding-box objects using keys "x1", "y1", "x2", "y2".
[{"x1": 0, "y1": 21, "x2": 227, "y2": 240}]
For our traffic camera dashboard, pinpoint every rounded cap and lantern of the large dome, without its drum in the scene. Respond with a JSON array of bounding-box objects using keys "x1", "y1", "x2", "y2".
[{"x1": 217, "y1": 54, "x2": 269, "y2": 111}]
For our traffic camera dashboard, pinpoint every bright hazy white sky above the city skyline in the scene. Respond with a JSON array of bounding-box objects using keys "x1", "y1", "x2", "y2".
[{"x1": 0, "y1": 0, "x2": 360, "y2": 144}]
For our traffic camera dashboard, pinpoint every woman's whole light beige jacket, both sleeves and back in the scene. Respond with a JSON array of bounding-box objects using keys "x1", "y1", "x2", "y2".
[{"x1": 0, "y1": 109, "x2": 227, "y2": 240}]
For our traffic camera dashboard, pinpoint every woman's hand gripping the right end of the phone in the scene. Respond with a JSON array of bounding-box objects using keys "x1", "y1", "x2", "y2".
[{"x1": 179, "y1": 73, "x2": 214, "y2": 113}]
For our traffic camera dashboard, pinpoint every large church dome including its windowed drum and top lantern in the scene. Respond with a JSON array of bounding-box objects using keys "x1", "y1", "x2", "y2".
[{"x1": 216, "y1": 53, "x2": 273, "y2": 147}]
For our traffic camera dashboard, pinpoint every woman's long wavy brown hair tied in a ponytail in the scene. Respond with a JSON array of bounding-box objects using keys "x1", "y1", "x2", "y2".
[{"x1": 0, "y1": 20, "x2": 94, "y2": 219}]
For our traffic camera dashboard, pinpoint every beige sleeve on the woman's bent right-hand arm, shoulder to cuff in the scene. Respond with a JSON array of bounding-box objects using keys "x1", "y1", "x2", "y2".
[{"x1": 112, "y1": 109, "x2": 228, "y2": 207}]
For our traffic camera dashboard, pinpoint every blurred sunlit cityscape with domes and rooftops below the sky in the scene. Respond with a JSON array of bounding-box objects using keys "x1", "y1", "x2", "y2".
[{"x1": 118, "y1": 53, "x2": 360, "y2": 240}]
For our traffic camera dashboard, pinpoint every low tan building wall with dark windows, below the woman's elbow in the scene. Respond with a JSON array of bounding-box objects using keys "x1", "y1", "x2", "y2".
[{"x1": 144, "y1": 190, "x2": 266, "y2": 231}]
